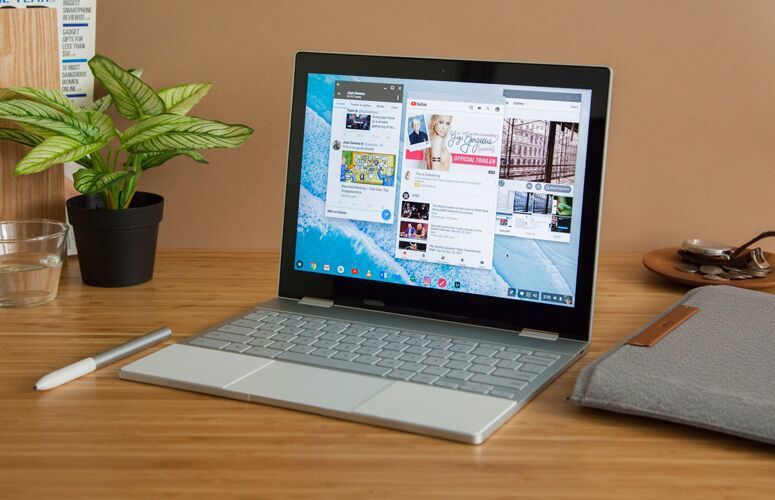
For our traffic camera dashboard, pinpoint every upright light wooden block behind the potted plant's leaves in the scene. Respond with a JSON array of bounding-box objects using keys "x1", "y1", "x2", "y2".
[{"x1": 0, "y1": 9, "x2": 65, "y2": 221}]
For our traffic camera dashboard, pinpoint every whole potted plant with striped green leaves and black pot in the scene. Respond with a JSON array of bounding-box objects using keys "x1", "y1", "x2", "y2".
[{"x1": 0, "y1": 55, "x2": 253, "y2": 287}]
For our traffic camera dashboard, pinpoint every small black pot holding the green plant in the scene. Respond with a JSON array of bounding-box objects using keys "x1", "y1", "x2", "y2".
[{"x1": 67, "y1": 192, "x2": 164, "y2": 287}]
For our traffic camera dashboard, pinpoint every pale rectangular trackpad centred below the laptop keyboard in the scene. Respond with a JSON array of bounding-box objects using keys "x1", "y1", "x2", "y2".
[{"x1": 225, "y1": 361, "x2": 394, "y2": 412}]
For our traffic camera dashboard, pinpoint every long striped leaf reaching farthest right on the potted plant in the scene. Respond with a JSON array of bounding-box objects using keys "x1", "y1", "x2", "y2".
[{"x1": 121, "y1": 115, "x2": 253, "y2": 153}]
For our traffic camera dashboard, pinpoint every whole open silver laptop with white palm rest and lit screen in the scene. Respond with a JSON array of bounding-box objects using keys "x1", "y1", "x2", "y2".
[{"x1": 120, "y1": 53, "x2": 611, "y2": 444}]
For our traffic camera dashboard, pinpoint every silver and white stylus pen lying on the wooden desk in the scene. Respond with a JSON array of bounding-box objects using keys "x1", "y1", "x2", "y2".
[{"x1": 33, "y1": 326, "x2": 172, "y2": 391}]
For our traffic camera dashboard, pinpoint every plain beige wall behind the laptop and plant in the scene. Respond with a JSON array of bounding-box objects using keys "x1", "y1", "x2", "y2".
[{"x1": 97, "y1": 0, "x2": 775, "y2": 251}]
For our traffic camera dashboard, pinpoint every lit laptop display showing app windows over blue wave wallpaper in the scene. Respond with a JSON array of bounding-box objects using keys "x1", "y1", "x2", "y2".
[{"x1": 294, "y1": 73, "x2": 591, "y2": 307}]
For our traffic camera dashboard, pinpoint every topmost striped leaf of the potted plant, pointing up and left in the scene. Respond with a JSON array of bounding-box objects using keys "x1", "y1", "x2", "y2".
[{"x1": 89, "y1": 55, "x2": 164, "y2": 120}]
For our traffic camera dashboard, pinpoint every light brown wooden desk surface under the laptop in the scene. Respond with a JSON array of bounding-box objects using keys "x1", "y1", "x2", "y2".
[{"x1": 0, "y1": 252, "x2": 775, "y2": 498}]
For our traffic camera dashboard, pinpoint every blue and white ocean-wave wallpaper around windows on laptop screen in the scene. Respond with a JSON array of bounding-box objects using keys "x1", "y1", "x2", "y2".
[{"x1": 295, "y1": 74, "x2": 584, "y2": 307}]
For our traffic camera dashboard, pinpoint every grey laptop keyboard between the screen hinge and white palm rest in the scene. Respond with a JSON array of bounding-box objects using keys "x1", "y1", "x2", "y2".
[{"x1": 188, "y1": 309, "x2": 562, "y2": 400}]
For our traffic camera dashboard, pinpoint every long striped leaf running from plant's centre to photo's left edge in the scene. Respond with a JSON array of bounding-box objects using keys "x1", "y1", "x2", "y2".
[{"x1": 0, "y1": 99, "x2": 99, "y2": 144}]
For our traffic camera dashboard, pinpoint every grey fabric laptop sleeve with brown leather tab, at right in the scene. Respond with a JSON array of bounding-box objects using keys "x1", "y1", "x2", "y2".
[{"x1": 570, "y1": 285, "x2": 775, "y2": 444}]
